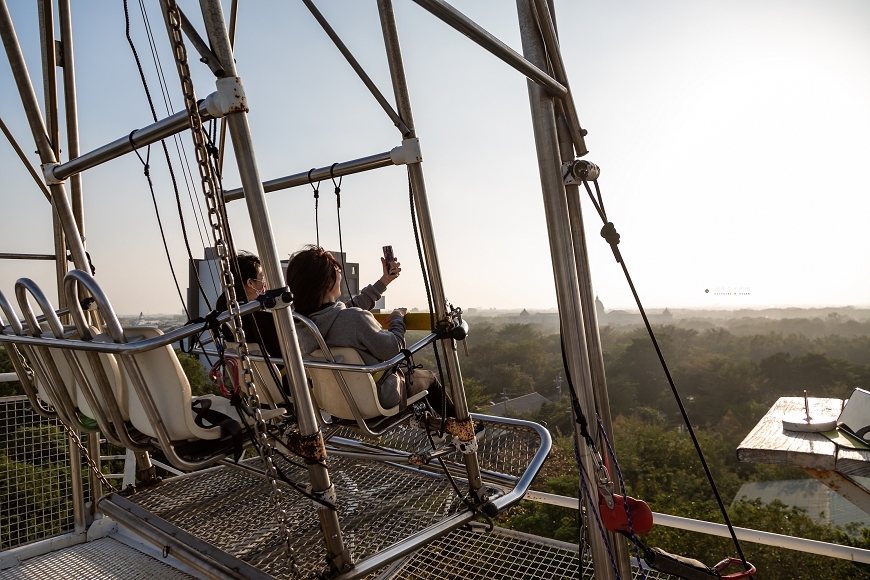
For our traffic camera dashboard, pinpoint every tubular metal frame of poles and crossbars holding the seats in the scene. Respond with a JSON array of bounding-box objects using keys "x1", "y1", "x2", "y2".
[{"x1": 0, "y1": 0, "x2": 630, "y2": 579}]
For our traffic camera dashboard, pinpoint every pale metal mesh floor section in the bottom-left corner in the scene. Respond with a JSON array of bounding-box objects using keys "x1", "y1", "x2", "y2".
[{"x1": 0, "y1": 538, "x2": 193, "y2": 580}]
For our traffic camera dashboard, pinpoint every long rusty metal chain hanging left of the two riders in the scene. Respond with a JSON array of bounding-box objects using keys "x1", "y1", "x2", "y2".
[{"x1": 165, "y1": 0, "x2": 301, "y2": 578}]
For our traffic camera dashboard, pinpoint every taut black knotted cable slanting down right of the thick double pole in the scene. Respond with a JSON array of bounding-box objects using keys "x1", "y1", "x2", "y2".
[{"x1": 583, "y1": 179, "x2": 750, "y2": 570}]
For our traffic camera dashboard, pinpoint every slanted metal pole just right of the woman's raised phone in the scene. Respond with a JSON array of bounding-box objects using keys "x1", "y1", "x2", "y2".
[{"x1": 378, "y1": 0, "x2": 486, "y2": 503}]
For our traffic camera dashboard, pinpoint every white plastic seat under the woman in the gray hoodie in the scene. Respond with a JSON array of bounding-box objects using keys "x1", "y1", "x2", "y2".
[{"x1": 306, "y1": 347, "x2": 428, "y2": 420}]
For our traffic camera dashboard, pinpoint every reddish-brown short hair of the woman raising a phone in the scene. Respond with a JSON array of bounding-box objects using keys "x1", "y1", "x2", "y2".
[{"x1": 287, "y1": 245, "x2": 341, "y2": 316}]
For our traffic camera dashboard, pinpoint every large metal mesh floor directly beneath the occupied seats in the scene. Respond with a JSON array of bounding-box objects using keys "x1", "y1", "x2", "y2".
[{"x1": 128, "y1": 457, "x2": 496, "y2": 578}]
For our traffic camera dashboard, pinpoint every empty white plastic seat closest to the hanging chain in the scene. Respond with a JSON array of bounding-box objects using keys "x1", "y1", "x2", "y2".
[{"x1": 122, "y1": 326, "x2": 284, "y2": 441}]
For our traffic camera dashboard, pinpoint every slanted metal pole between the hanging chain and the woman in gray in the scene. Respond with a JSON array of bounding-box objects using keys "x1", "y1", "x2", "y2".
[{"x1": 200, "y1": 0, "x2": 353, "y2": 571}]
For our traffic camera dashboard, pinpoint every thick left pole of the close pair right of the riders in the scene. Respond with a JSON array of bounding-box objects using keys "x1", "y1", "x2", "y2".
[{"x1": 517, "y1": 0, "x2": 630, "y2": 580}]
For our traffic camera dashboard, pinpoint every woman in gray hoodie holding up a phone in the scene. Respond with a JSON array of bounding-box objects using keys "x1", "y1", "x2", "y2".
[{"x1": 287, "y1": 246, "x2": 455, "y2": 416}]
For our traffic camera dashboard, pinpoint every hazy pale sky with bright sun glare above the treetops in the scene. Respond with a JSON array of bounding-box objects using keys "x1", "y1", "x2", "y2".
[{"x1": 0, "y1": 0, "x2": 870, "y2": 313}]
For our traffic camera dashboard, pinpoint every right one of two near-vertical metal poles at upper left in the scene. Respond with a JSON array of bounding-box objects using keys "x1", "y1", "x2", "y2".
[{"x1": 57, "y1": 0, "x2": 85, "y2": 238}]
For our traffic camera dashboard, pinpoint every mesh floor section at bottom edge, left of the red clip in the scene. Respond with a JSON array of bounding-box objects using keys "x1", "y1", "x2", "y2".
[{"x1": 378, "y1": 529, "x2": 676, "y2": 580}]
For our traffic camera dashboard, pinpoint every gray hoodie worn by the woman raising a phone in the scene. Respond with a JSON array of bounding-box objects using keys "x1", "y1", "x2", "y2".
[{"x1": 296, "y1": 280, "x2": 405, "y2": 409}]
